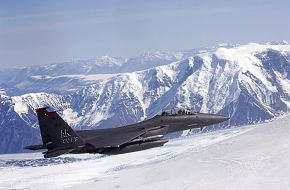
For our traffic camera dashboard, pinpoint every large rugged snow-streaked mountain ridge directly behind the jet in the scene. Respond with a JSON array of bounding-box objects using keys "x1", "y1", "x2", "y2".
[{"x1": 0, "y1": 43, "x2": 290, "y2": 153}]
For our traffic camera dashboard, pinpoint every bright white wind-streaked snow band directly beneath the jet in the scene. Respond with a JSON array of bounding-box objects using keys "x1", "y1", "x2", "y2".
[{"x1": 0, "y1": 127, "x2": 251, "y2": 189}]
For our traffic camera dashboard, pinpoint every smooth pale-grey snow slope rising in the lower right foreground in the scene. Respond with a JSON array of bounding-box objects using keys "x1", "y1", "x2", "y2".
[{"x1": 73, "y1": 113, "x2": 290, "y2": 190}]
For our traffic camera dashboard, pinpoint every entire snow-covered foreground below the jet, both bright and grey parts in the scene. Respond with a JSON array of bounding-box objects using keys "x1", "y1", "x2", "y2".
[{"x1": 0, "y1": 116, "x2": 290, "y2": 190}]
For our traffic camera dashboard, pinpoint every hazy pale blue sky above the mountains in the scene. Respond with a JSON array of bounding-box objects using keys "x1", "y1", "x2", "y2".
[{"x1": 0, "y1": 0, "x2": 290, "y2": 69}]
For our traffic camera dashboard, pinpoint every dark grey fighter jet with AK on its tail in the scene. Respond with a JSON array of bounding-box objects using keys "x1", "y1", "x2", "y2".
[{"x1": 25, "y1": 108, "x2": 229, "y2": 158}]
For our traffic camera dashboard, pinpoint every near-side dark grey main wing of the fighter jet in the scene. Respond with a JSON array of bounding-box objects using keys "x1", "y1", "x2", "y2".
[{"x1": 87, "y1": 131, "x2": 145, "y2": 148}]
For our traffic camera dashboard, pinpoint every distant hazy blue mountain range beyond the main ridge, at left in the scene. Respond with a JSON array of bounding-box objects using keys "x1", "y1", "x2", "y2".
[{"x1": 0, "y1": 51, "x2": 183, "y2": 96}]
